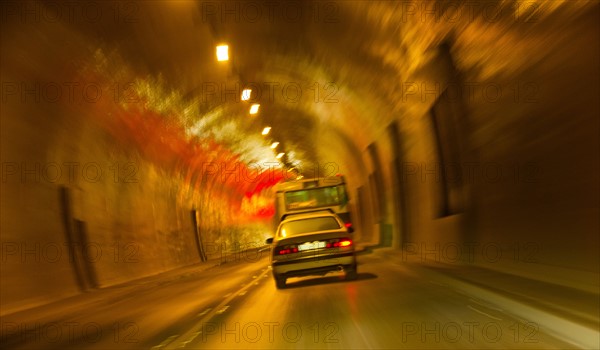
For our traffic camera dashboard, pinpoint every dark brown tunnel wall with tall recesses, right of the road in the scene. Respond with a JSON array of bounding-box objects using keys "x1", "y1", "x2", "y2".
[{"x1": 358, "y1": 7, "x2": 600, "y2": 293}]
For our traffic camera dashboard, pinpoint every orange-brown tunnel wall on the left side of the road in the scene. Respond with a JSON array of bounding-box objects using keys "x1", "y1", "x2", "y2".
[{"x1": 0, "y1": 20, "x2": 253, "y2": 314}]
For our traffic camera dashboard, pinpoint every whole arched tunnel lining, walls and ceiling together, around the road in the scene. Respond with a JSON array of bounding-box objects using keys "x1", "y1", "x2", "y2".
[{"x1": 0, "y1": 1, "x2": 599, "y2": 310}]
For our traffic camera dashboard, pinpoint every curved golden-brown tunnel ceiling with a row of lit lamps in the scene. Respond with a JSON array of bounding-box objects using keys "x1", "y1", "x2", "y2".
[{"x1": 16, "y1": 1, "x2": 588, "y2": 186}]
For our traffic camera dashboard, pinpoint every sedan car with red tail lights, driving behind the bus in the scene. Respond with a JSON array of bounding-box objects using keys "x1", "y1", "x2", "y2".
[{"x1": 266, "y1": 211, "x2": 357, "y2": 289}]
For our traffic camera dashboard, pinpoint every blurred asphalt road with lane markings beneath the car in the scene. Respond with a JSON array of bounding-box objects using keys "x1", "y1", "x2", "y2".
[{"x1": 4, "y1": 252, "x2": 573, "y2": 349}]
